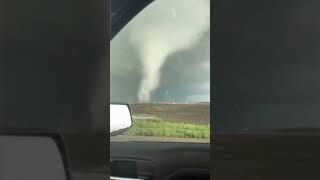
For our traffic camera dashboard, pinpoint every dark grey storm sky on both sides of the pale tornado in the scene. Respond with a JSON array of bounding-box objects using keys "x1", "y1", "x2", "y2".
[{"x1": 111, "y1": 1, "x2": 210, "y2": 103}]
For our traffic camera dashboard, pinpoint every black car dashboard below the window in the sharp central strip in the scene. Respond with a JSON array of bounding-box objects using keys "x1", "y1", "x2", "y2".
[{"x1": 110, "y1": 141, "x2": 210, "y2": 180}]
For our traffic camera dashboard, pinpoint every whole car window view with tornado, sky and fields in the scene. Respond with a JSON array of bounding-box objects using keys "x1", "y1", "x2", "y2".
[{"x1": 110, "y1": 0, "x2": 211, "y2": 142}]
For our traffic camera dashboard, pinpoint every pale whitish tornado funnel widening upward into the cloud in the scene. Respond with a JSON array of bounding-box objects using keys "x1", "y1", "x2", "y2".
[{"x1": 130, "y1": 0, "x2": 210, "y2": 102}]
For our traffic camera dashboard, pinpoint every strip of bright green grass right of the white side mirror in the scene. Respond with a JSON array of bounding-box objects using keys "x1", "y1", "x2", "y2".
[{"x1": 126, "y1": 119, "x2": 210, "y2": 139}]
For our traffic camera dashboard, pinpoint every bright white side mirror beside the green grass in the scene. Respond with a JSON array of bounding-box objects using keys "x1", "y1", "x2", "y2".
[{"x1": 110, "y1": 103, "x2": 133, "y2": 136}]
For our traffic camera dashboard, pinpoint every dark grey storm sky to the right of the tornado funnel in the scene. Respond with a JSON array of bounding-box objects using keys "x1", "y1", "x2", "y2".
[{"x1": 154, "y1": 31, "x2": 210, "y2": 102}]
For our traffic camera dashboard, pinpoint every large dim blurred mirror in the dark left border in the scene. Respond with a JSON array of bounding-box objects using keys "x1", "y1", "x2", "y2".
[{"x1": 0, "y1": 134, "x2": 70, "y2": 180}]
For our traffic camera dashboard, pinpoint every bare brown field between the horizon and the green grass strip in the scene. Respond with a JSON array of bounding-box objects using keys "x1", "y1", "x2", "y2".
[{"x1": 130, "y1": 103, "x2": 210, "y2": 124}]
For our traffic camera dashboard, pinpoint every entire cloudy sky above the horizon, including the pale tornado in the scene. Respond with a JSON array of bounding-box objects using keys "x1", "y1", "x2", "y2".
[{"x1": 110, "y1": 0, "x2": 210, "y2": 103}]
